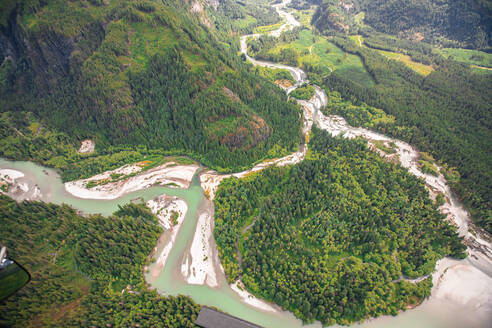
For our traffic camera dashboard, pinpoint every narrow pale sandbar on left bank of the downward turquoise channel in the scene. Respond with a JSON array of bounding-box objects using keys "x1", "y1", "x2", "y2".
[{"x1": 146, "y1": 195, "x2": 188, "y2": 278}]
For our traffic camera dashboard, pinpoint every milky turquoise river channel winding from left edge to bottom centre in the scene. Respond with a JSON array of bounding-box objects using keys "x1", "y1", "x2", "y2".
[{"x1": 0, "y1": 158, "x2": 320, "y2": 328}]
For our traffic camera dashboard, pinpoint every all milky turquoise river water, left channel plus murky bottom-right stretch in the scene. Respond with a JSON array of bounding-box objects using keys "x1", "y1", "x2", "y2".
[{"x1": 0, "y1": 159, "x2": 482, "y2": 328}]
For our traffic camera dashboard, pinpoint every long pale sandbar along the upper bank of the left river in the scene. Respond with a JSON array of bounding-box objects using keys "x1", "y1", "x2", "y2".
[{"x1": 65, "y1": 162, "x2": 199, "y2": 199}]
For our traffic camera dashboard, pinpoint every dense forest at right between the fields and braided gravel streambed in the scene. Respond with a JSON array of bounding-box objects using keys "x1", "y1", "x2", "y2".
[{"x1": 323, "y1": 38, "x2": 492, "y2": 232}]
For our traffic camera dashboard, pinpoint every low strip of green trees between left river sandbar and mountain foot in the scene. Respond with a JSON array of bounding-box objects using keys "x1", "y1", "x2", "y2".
[{"x1": 0, "y1": 112, "x2": 188, "y2": 181}]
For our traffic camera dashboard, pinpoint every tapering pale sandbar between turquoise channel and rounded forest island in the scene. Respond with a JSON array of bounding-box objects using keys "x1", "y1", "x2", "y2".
[{"x1": 181, "y1": 201, "x2": 218, "y2": 287}]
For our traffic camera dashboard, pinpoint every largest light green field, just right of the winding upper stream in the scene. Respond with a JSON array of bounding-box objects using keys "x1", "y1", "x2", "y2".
[{"x1": 270, "y1": 30, "x2": 374, "y2": 86}]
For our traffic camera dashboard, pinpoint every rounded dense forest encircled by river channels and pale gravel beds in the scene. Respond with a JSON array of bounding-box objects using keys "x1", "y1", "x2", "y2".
[{"x1": 214, "y1": 128, "x2": 466, "y2": 324}]
